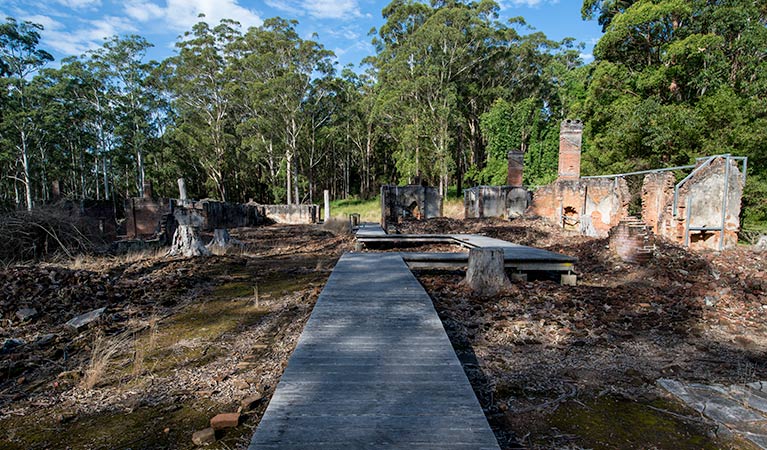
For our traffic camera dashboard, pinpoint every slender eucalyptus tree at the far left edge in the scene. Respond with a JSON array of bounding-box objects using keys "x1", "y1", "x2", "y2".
[{"x1": 0, "y1": 17, "x2": 53, "y2": 210}]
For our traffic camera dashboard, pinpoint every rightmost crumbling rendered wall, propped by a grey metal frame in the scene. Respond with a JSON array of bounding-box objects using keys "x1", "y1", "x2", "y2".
[{"x1": 657, "y1": 158, "x2": 743, "y2": 250}]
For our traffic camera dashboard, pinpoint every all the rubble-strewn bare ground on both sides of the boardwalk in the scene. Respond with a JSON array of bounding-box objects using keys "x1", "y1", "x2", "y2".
[{"x1": 0, "y1": 219, "x2": 767, "y2": 450}]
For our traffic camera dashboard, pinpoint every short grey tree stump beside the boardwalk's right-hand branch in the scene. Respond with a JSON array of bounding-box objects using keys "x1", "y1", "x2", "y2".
[{"x1": 461, "y1": 248, "x2": 511, "y2": 297}]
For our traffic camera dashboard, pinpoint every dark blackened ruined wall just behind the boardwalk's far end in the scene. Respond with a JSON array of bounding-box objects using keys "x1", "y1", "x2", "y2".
[{"x1": 381, "y1": 185, "x2": 442, "y2": 227}]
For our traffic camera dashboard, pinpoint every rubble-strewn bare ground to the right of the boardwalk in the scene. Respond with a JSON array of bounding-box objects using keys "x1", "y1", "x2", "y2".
[{"x1": 400, "y1": 219, "x2": 767, "y2": 449}]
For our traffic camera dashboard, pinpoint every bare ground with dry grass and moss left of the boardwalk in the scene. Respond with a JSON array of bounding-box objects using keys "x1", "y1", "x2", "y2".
[{"x1": 0, "y1": 225, "x2": 351, "y2": 449}]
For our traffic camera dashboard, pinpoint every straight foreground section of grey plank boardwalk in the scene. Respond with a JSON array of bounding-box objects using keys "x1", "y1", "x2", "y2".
[{"x1": 249, "y1": 253, "x2": 499, "y2": 450}]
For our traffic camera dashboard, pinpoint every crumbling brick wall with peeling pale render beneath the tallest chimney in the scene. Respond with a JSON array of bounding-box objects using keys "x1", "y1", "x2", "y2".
[{"x1": 528, "y1": 177, "x2": 630, "y2": 237}]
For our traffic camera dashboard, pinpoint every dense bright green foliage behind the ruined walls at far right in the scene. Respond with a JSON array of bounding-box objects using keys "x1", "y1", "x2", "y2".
[{"x1": 583, "y1": 0, "x2": 767, "y2": 229}]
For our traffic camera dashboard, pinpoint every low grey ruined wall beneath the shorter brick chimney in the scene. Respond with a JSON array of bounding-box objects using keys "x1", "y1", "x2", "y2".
[{"x1": 463, "y1": 186, "x2": 531, "y2": 219}]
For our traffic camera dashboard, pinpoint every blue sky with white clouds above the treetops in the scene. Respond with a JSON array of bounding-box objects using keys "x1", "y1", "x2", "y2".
[{"x1": 0, "y1": 0, "x2": 601, "y2": 67}]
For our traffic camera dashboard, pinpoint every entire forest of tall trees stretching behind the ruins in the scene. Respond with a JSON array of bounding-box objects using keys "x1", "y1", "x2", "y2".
[{"x1": 0, "y1": 0, "x2": 767, "y2": 229}]
